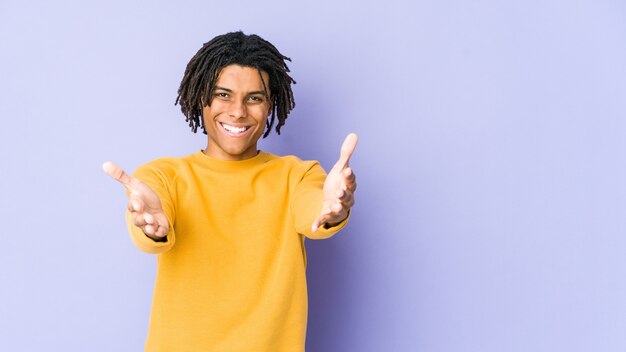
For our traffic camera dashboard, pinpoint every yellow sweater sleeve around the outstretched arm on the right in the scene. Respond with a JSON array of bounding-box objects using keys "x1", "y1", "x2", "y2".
[{"x1": 291, "y1": 162, "x2": 349, "y2": 239}]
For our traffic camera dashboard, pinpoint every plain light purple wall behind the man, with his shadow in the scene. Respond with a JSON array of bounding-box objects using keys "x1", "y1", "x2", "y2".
[{"x1": 0, "y1": 0, "x2": 626, "y2": 352}]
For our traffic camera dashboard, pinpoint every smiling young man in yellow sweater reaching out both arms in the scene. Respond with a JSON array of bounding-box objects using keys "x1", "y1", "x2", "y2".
[{"x1": 103, "y1": 32, "x2": 357, "y2": 352}]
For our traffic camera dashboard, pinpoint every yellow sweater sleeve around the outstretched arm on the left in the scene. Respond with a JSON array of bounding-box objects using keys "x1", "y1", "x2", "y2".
[{"x1": 126, "y1": 165, "x2": 176, "y2": 254}]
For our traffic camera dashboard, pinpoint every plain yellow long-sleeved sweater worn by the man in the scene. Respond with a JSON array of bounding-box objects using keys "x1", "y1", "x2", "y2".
[{"x1": 127, "y1": 151, "x2": 347, "y2": 352}]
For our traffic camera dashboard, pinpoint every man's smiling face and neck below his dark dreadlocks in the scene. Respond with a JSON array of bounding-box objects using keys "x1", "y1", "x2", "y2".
[{"x1": 202, "y1": 65, "x2": 271, "y2": 160}]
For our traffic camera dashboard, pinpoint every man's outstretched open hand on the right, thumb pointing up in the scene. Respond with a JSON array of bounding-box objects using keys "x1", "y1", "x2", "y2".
[{"x1": 311, "y1": 133, "x2": 358, "y2": 232}]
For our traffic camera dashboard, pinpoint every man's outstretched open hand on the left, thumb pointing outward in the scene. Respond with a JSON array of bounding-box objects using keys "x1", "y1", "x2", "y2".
[{"x1": 102, "y1": 161, "x2": 170, "y2": 241}]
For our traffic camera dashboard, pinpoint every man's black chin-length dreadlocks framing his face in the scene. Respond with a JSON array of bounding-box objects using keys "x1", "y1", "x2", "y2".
[{"x1": 174, "y1": 31, "x2": 296, "y2": 138}]
